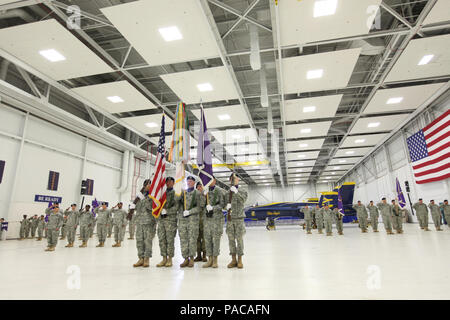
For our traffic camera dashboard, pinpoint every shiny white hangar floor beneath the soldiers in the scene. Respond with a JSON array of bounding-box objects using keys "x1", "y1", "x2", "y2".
[{"x1": 0, "y1": 224, "x2": 450, "y2": 300}]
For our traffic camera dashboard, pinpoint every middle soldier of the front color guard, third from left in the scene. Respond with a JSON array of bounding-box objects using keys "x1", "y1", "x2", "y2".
[{"x1": 177, "y1": 176, "x2": 203, "y2": 268}]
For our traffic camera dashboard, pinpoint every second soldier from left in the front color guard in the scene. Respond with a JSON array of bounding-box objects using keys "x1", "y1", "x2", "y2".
[{"x1": 156, "y1": 177, "x2": 179, "y2": 268}]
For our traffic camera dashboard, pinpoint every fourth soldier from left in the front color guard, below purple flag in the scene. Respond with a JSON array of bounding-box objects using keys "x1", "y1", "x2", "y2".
[{"x1": 203, "y1": 178, "x2": 225, "y2": 268}]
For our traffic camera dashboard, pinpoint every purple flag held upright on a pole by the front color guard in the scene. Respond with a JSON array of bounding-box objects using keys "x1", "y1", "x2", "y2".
[{"x1": 197, "y1": 105, "x2": 213, "y2": 187}]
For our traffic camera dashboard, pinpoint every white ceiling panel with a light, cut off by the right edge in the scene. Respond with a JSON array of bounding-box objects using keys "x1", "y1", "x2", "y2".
[{"x1": 386, "y1": 34, "x2": 450, "y2": 82}]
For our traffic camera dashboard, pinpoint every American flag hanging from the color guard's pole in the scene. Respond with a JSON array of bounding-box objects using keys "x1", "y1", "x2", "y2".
[{"x1": 148, "y1": 115, "x2": 166, "y2": 218}]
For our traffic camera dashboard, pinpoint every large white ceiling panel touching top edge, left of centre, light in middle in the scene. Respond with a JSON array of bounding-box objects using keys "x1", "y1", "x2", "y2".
[{"x1": 101, "y1": 0, "x2": 219, "y2": 66}]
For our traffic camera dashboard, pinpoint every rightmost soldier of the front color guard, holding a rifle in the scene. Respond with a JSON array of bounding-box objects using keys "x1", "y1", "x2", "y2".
[{"x1": 225, "y1": 173, "x2": 248, "y2": 269}]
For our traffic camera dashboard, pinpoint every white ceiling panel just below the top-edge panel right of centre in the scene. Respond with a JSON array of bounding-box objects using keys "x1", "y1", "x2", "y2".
[{"x1": 282, "y1": 48, "x2": 361, "y2": 93}]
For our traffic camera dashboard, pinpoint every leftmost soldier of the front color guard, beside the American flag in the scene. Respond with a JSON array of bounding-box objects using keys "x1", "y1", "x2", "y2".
[{"x1": 130, "y1": 180, "x2": 158, "y2": 268}]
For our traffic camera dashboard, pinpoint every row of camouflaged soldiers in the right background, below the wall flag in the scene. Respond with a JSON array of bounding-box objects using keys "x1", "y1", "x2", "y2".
[{"x1": 302, "y1": 198, "x2": 450, "y2": 236}]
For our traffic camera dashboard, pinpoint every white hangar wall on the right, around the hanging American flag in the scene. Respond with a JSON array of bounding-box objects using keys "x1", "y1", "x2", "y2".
[{"x1": 340, "y1": 99, "x2": 450, "y2": 220}]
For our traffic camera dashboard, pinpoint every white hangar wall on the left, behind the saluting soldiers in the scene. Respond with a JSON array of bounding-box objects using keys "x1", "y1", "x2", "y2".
[{"x1": 0, "y1": 105, "x2": 149, "y2": 238}]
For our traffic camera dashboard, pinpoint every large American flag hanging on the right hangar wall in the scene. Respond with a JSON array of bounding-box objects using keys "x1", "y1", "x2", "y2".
[{"x1": 406, "y1": 109, "x2": 450, "y2": 184}]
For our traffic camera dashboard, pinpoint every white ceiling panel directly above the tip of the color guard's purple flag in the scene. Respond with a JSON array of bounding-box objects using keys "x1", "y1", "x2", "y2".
[{"x1": 161, "y1": 67, "x2": 239, "y2": 103}]
